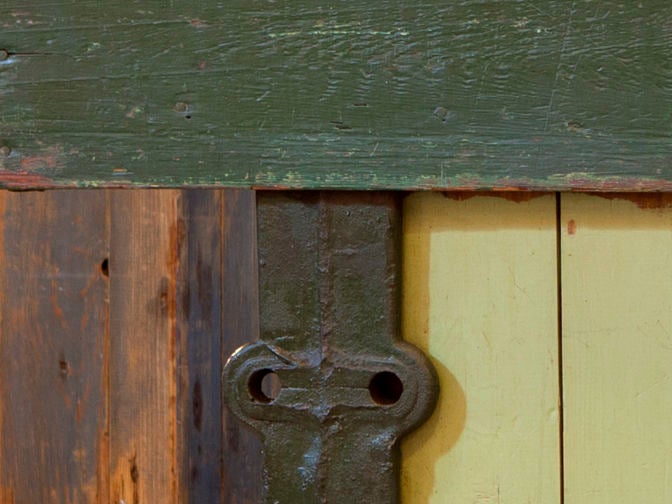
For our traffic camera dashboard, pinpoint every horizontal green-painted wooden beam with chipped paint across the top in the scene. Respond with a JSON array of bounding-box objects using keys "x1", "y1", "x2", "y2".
[{"x1": 0, "y1": 0, "x2": 672, "y2": 190}]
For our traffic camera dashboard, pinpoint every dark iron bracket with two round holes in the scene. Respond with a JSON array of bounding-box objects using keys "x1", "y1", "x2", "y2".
[{"x1": 224, "y1": 192, "x2": 438, "y2": 504}]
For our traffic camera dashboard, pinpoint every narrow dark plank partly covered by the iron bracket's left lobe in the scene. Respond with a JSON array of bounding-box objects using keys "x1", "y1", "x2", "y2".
[{"x1": 221, "y1": 190, "x2": 263, "y2": 504}]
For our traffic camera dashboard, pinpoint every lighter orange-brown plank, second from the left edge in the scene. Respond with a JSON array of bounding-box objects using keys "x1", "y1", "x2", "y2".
[{"x1": 109, "y1": 191, "x2": 184, "y2": 504}]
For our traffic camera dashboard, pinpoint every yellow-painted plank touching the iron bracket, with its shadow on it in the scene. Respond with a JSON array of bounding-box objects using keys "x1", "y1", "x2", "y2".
[{"x1": 402, "y1": 193, "x2": 560, "y2": 504}]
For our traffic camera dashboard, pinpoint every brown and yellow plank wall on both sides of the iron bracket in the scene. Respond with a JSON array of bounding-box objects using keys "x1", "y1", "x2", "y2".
[{"x1": 0, "y1": 190, "x2": 672, "y2": 504}]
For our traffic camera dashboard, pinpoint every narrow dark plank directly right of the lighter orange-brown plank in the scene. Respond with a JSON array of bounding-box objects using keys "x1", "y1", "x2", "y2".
[{"x1": 177, "y1": 190, "x2": 227, "y2": 504}]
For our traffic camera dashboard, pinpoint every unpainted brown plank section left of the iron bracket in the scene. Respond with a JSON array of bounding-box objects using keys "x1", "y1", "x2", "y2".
[{"x1": 0, "y1": 190, "x2": 261, "y2": 504}]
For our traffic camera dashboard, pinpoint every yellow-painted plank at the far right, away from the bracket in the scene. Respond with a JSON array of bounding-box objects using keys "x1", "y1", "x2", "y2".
[{"x1": 562, "y1": 195, "x2": 672, "y2": 504}]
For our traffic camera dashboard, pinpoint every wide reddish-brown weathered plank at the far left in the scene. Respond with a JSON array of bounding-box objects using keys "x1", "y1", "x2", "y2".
[{"x1": 0, "y1": 191, "x2": 110, "y2": 504}]
